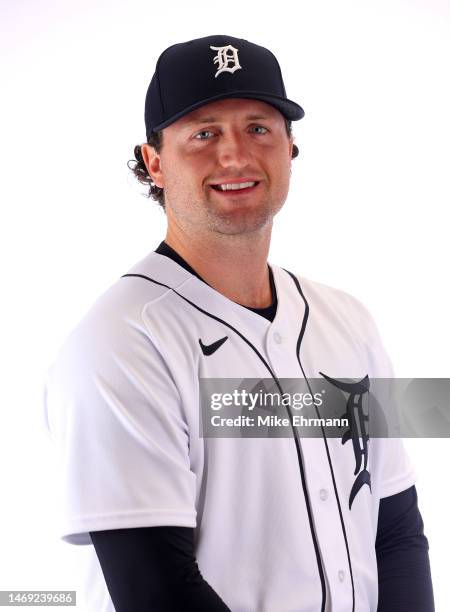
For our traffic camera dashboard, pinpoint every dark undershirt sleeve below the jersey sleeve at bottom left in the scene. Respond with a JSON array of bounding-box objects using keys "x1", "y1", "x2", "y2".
[{"x1": 90, "y1": 527, "x2": 230, "y2": 612}]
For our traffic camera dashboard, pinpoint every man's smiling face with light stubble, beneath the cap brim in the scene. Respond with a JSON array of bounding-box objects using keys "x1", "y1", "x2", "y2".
[{"x1": 144, "y1": 98, "x2": 293, "y2": 235}]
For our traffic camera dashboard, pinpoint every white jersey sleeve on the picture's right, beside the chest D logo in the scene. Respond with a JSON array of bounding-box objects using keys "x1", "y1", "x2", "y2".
[{"x1": 344, "y1": 298, "x2": 417, "y2": 499}]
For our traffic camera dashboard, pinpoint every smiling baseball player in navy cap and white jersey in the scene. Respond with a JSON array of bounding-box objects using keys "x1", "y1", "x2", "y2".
[{"x1": 45, "y1": 35, "x2": 433, "y2": 612}]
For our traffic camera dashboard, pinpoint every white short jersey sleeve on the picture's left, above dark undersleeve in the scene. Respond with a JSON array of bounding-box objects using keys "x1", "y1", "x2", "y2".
[{"x1": 44, "y1": 302, "x2": 196, "y2": 544}]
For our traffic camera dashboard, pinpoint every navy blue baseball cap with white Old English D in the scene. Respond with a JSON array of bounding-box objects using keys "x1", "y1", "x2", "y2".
[{"x1": 145, "y1": 34, "x2": 305, "y2": 136}]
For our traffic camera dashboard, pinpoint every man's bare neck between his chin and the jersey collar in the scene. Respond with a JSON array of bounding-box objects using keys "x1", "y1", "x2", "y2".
[{"x1": 165, "y1": 229, "x2": 274, "y2": 308}]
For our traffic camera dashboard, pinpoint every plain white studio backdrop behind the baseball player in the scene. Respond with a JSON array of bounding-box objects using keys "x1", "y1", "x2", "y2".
[{"x1": 0, "y1": 0, "x2": 450, "y2": 612}]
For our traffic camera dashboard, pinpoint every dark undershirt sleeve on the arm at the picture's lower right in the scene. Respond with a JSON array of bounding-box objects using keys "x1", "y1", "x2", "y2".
[{"x1": 375, "y1": 486, "x2": 434, "y2": 612}]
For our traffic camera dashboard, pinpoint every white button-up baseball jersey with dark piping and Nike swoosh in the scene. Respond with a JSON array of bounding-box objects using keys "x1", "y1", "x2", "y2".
[{"x1": 45, "y1": 252, "x2": 416, "y2": 612}]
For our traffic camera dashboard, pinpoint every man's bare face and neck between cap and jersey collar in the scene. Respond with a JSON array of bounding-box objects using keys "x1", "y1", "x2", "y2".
[{"x1": 142, "y1": 98, "x2": 293, "y2": 307}]
